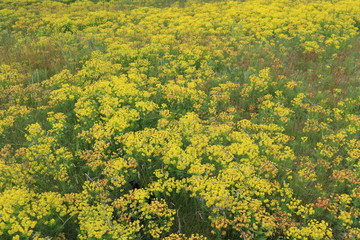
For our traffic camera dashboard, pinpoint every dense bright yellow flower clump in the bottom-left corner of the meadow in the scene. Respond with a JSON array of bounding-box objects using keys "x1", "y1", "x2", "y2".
[{"x1": 0, "y1": 188, "x2": 68, "y2": 239}]
